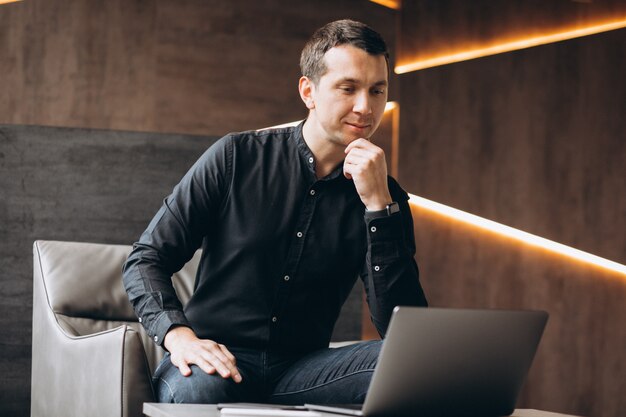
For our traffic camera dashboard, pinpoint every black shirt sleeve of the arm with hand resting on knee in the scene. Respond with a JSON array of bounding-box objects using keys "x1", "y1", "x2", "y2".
[{"x1": 123, "y1": 136, "x2": 232, "y2": 345}]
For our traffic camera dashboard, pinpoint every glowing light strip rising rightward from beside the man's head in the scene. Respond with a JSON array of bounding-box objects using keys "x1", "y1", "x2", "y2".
[{"x1": 394, "y1": 20, "x2": 626, "y2": 74}]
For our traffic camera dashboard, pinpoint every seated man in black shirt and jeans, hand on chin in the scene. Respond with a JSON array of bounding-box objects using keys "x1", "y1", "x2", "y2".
[{"x1": 124, "y1": 20, "x2": 426, "y2": 404}]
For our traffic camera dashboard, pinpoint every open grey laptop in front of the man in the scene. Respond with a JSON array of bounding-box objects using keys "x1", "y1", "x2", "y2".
[{"x1": 305, "y1": 307, "x2": 548, "y2": 417}]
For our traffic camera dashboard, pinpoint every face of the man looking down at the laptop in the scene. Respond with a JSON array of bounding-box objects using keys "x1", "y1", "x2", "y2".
[{"x1": 307, "y1": 45, "x2": 388, "y2": 146}]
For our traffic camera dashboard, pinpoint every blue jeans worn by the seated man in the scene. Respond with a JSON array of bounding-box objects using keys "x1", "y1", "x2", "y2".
[{"x1": 153, "y1": 341, "x2": 382, "y2": 404}]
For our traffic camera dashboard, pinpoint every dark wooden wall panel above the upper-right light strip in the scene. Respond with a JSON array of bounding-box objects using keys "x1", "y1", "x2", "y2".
[{"x1": 398, "y1": 0, "x2": 626, "y2": 65}]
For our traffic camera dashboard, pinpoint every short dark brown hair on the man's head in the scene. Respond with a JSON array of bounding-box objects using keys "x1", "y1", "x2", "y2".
[{"x1": 300, "y1": 19, "x2": 389, "y2": 83}]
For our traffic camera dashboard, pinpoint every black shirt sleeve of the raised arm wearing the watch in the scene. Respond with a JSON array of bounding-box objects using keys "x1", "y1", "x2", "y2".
[{"x1": 360, "y1": 177, "x2": 428, "y2": 338}]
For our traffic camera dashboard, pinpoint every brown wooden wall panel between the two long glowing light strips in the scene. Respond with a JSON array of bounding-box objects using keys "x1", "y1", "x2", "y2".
[{"x1": 399, "y1": 30, "x2": 626, "y2": 263}]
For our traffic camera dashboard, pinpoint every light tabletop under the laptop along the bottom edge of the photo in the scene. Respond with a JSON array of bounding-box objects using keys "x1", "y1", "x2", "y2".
[{"x1": 143, "y1": 403, "x2": 573, "y2": 417}]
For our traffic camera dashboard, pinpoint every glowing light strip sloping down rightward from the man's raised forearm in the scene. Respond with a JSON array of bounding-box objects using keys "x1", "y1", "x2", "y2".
[{"x1": 409, "y1": 194, "x2": 626, "y2": 275}]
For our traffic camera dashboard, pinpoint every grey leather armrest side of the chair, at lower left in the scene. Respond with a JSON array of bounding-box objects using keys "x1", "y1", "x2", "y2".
[{"x1": 31, "y1": 247, "x2": 154, "y2": 417}]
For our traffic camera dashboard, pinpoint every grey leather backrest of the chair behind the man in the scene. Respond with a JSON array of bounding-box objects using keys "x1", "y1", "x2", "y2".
[{"x1": 37, "y1": 241, "x2": 200, "y2": 371}]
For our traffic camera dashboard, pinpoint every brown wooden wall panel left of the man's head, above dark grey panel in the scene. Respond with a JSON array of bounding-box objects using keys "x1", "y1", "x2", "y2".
[{"x1": 0, "y1": 0, "x2": 396, "y2": 135}]
